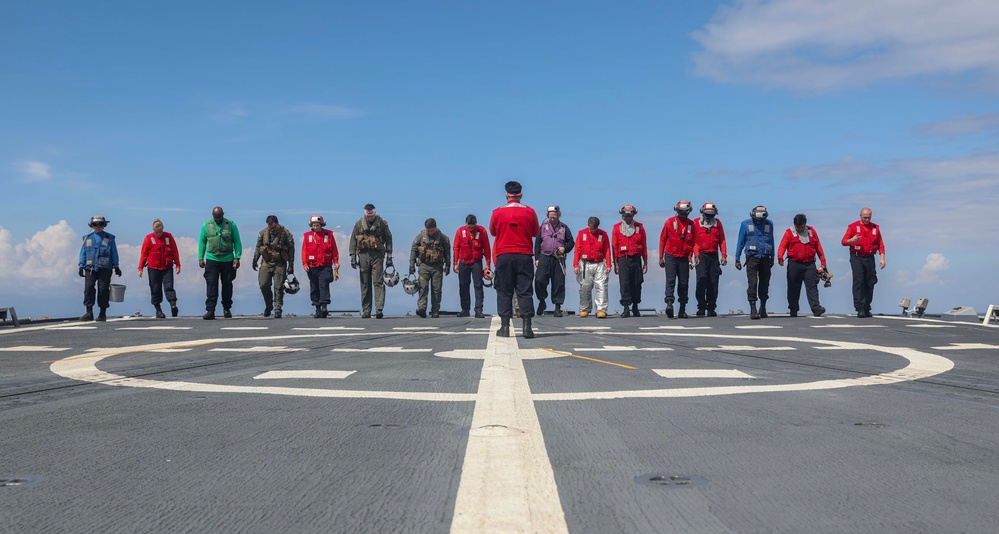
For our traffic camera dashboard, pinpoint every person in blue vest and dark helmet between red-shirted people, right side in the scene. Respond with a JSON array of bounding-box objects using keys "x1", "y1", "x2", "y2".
[{"x1": 735, "y1": 206, "x2": 776, "y2": 319}]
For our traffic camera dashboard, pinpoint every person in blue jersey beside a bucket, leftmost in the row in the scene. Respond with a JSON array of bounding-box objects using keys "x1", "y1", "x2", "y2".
[{"x1": 79, "y1": 215, "x2": 121, "y2": 321}]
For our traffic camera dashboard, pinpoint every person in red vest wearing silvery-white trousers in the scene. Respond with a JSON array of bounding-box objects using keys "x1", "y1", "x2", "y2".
[{"x1": 572, "y1": 217, "x2": 611, "y2": 319}]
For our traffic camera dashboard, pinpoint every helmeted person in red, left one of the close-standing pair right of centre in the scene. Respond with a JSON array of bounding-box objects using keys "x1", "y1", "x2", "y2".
[{"x1": 659, "y1": 200, "x2": 694, "y2": 319}]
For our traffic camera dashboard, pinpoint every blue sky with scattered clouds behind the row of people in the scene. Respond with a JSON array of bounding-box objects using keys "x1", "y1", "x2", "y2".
[{"x1": 0, "y1": 0, "x2": 999, "y2": 317}]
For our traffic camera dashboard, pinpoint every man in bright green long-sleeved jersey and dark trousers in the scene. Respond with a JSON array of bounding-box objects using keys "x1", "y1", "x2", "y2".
[{"x1": 198, "y1": 206, "x2": 243, "y2": 319}]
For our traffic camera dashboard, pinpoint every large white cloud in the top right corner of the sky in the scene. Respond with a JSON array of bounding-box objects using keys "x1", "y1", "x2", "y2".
[{"x1": 691, "y1": 0, "x2": 999, "y2": 92}]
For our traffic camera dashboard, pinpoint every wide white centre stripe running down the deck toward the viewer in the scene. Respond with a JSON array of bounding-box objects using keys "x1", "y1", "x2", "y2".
[{"x1": 451, "y1": 317, "x2": 569, "y2": 534}]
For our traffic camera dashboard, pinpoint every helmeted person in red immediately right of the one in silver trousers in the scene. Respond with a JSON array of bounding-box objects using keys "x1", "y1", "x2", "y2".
[{"x1": 611, "y1": 204, "x2": 649, "y2": 318}]
